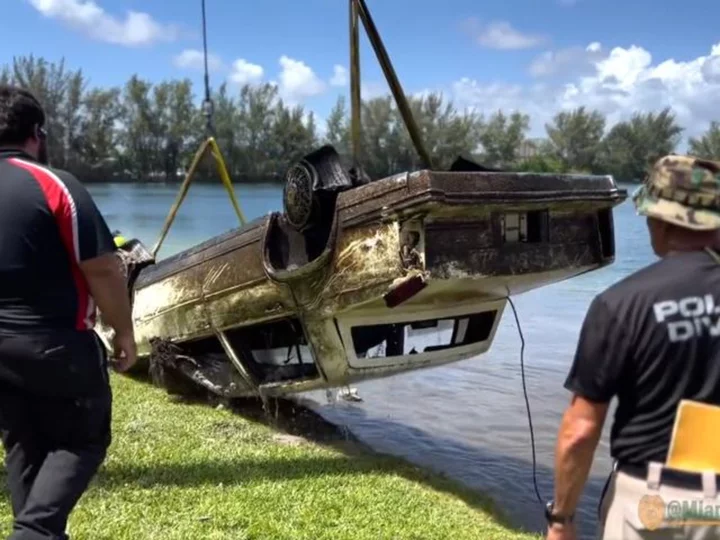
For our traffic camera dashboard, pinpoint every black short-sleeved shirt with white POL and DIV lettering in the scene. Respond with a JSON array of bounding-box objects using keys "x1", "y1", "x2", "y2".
[{"x1": 565, "y1": 251, "x2": 720, "y2": 463}]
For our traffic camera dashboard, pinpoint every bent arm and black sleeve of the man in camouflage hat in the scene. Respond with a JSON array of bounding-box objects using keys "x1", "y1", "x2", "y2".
[{"x1": 553, "y1": 297, "x2": 626, "y2": 527}]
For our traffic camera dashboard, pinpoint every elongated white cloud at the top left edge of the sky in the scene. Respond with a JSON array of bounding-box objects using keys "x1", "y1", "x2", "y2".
[{"x1": 27, "y1": 0, "x2": 179, "y2": 47}]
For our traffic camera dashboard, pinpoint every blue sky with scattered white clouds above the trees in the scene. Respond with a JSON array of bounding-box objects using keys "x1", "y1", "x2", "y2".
[{"x1": 0, "y1": 0, "x2": 720, "y2": 142}]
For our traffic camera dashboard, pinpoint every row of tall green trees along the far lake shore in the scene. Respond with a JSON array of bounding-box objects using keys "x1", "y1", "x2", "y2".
[{"x1": 0, "y1": 55, "x2": 720, "y2": 183}]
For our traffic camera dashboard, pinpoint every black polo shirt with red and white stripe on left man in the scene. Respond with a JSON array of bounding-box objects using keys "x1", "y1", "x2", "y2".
[{"x1": 0, "y1": 151, "x2": 115, "y2": 335}]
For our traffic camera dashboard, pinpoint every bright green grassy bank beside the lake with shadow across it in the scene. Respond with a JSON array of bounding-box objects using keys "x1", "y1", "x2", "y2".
[{"x1": 0, "y1": 375, "x2": 538, "y2": 540}]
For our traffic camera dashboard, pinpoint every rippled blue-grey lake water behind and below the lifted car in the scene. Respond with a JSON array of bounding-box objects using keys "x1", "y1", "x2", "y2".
[{"x1": 90, "y1": 180, "x2": 655, "y2": 538}]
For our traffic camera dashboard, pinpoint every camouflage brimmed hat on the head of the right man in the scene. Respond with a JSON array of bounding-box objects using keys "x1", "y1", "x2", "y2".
[{"x1": 632, "y1": 155, "x2": 720, "y2": 231}]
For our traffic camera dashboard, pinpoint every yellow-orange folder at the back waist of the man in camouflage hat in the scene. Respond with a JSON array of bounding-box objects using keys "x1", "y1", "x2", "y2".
[{"x1": 665, "y1": 399, "x2": 720, "y2": 473}]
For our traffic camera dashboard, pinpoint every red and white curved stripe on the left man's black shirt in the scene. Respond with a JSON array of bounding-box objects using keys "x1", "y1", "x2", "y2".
[{"x1": 8, "y1": 158, "x2": 95, "y2": 330}]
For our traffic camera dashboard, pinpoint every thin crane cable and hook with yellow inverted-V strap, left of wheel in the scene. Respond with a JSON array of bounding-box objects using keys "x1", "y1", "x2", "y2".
[{"x1": 152, "y1": 0, "x2": 246, "y2": 257}]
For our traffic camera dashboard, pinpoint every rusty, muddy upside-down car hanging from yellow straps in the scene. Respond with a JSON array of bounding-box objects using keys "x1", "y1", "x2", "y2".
[{"x1": 98, "y1": 147, "x2": 627, "y2": 397}]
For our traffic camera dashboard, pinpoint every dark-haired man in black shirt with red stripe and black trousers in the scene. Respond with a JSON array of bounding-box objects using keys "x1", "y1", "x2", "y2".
[{"x1": 0, "y1": 86, "x2": 136, "y2": 540}]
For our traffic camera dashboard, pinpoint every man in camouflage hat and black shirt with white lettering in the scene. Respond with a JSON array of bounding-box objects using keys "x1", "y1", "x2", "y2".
[{"x1": 546, "y1": 156, "x2": 720, "y2": 540}]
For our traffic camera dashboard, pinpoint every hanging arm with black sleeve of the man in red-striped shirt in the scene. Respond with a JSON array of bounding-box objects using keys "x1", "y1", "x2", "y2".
[{"x1": 58, "y1": 171, "x2": 134, "y2": 337}]
